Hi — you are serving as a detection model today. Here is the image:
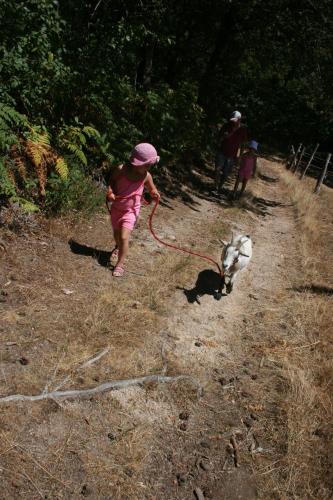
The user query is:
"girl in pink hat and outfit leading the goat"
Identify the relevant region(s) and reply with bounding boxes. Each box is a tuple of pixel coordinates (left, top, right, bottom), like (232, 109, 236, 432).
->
(106, 143, 160, 277)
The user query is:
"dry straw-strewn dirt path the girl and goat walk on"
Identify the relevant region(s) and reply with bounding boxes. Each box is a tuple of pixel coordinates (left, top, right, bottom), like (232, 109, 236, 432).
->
(0, 161, 297, 499)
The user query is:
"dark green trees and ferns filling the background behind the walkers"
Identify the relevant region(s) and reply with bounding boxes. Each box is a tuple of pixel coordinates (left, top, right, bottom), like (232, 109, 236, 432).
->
(0, 0, 333, 219)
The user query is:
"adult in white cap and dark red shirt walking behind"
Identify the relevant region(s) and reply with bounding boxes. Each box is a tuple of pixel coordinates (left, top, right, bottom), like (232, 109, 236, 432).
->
(214, 111, 247, 194)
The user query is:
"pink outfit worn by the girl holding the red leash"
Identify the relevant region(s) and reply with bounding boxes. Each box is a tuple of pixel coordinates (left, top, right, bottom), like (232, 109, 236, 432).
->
(111, 172, 145, 231)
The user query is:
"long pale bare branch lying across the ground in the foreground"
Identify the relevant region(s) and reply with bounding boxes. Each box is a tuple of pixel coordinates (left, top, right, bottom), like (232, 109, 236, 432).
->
(0, 375, 203, 403)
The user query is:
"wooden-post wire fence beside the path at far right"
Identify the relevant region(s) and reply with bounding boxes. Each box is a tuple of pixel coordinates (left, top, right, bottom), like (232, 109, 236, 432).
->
(286, 143, 333, 193)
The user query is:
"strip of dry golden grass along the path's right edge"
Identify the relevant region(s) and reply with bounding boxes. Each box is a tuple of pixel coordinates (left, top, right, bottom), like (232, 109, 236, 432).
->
(265, 171, 333, 499)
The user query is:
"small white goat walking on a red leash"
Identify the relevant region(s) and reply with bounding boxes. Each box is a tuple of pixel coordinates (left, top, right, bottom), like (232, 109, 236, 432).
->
(221, 234, 252, 293)
